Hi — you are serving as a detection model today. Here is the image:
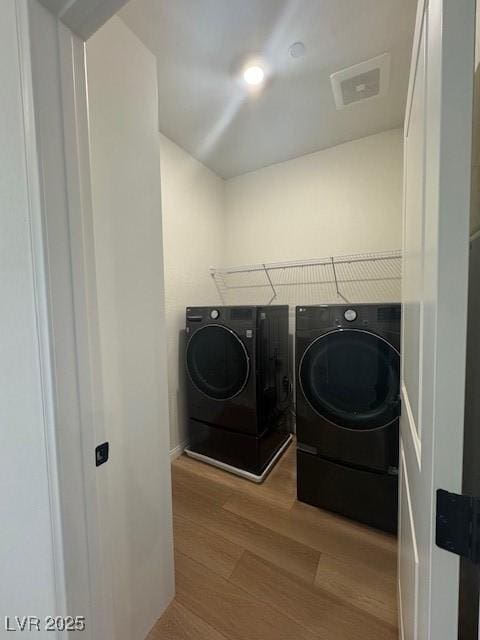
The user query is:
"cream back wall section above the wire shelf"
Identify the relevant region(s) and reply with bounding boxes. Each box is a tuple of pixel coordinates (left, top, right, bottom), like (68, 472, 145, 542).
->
(225, 130, 403, 265)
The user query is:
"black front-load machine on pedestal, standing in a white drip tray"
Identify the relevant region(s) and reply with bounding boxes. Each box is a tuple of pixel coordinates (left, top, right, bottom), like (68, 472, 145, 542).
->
(185, 306, 291, 481)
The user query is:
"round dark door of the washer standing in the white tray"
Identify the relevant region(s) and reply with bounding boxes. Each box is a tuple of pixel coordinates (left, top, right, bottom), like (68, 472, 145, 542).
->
(187, 324, 250, 400)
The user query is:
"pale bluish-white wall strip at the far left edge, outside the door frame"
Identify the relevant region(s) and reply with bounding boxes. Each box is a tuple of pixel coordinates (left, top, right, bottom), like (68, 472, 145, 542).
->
(0, 0, 61, 638)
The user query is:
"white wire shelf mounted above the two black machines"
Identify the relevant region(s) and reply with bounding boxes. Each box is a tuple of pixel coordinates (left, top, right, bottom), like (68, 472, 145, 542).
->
(210, 251, 402, 306)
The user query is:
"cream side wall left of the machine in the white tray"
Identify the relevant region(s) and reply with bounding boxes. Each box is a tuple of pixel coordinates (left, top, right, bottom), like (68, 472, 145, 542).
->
(160, 134, 225, 457)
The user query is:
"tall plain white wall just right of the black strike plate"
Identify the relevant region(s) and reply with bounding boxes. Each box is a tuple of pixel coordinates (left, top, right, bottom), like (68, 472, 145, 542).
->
(87, 18, 174, 640)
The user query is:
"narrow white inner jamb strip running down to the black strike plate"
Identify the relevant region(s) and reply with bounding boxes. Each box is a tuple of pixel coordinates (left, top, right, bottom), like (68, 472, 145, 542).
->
(59, 24, 114, 640)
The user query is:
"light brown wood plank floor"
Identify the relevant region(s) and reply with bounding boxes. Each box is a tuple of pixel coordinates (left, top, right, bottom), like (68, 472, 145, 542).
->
(147, 445, 398, 640)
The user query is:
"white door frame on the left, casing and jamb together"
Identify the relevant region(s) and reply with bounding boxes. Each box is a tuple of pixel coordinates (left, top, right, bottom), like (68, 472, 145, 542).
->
(15, 0, 129, 640)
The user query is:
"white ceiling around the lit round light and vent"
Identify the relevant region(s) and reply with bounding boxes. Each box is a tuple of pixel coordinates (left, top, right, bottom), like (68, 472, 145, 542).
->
(119, 0, 416, 178)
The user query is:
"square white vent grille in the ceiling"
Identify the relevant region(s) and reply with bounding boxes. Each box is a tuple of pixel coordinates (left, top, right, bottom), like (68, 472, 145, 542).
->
(330, 53, 390, 109)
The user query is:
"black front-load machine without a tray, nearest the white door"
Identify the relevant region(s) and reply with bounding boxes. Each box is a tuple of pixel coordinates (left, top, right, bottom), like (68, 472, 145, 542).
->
(296, 304, 401, 532)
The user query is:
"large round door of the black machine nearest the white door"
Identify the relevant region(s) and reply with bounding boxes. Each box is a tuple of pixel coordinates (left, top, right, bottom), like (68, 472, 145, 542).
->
(299, 329, 400, 430)
